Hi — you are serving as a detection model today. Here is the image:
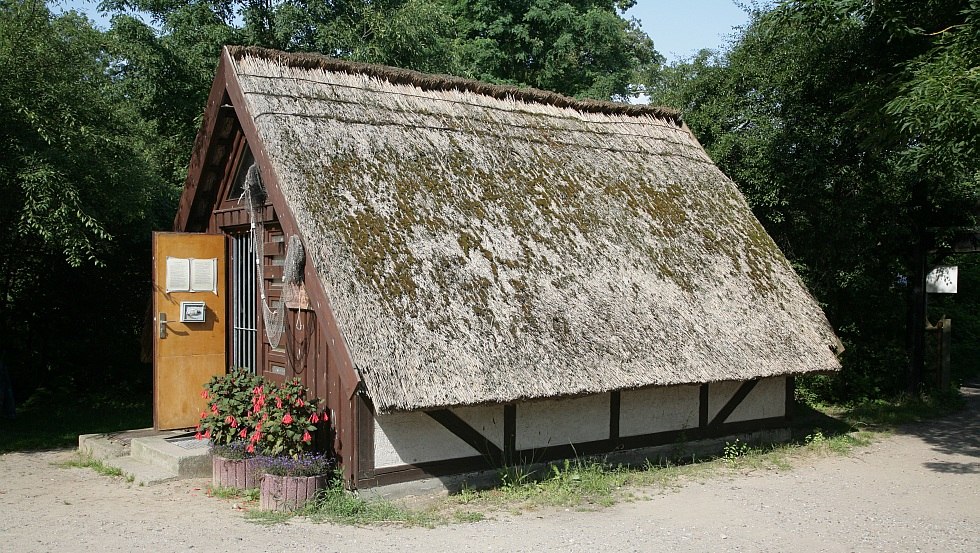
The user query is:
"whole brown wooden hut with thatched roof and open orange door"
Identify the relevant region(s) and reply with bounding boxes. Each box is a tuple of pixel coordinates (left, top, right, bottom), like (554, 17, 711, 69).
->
(154, 47, 841, 488)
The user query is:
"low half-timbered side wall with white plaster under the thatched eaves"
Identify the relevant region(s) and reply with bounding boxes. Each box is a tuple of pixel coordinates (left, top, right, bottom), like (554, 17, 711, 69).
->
(358, 377, 793, 487)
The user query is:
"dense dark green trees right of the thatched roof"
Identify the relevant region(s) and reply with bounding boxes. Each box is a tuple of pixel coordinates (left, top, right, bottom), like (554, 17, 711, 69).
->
(653, 0, 980, 398)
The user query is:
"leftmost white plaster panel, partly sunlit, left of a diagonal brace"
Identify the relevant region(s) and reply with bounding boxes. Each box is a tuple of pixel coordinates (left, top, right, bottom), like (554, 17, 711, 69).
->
(374, 413, 479, 468)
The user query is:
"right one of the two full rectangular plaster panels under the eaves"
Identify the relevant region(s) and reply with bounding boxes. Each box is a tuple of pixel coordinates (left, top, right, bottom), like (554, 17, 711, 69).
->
(619, 386, 701, 436)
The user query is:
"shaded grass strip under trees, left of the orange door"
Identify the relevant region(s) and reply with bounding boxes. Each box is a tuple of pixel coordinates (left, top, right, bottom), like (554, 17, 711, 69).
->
(0, 388, 153, 454)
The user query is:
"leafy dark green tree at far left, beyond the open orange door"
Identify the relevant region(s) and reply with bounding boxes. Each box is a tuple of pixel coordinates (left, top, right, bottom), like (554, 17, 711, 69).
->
(0, 0, 173, 394)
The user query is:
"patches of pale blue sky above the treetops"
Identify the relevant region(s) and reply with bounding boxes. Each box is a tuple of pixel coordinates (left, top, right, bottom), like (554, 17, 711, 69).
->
(60, 0, 748, 61)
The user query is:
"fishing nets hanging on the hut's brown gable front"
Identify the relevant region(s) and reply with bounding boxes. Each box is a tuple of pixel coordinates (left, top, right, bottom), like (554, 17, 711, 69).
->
(239, 163, 306, 348)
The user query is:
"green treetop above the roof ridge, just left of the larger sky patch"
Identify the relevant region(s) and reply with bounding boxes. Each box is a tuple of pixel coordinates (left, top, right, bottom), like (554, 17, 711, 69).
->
(446, 0, 663, 100)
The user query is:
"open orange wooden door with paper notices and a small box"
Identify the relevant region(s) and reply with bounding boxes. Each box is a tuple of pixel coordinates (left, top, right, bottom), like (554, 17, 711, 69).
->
(153, 232, 227, 430)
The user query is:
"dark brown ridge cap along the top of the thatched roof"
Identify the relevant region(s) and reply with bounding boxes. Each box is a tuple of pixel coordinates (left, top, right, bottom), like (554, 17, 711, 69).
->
(225, 46, 683, 127)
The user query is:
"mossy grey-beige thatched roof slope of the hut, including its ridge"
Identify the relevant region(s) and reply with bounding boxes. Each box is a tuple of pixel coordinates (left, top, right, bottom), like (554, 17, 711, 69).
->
(224, 49, 840, 412)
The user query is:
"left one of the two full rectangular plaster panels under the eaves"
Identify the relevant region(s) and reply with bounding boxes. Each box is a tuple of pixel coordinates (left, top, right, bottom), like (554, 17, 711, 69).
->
(517, 394, 609, 450)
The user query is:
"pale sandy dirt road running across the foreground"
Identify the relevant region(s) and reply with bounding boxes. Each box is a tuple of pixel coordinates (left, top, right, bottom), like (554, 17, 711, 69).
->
(0, 388, 980, 553)
